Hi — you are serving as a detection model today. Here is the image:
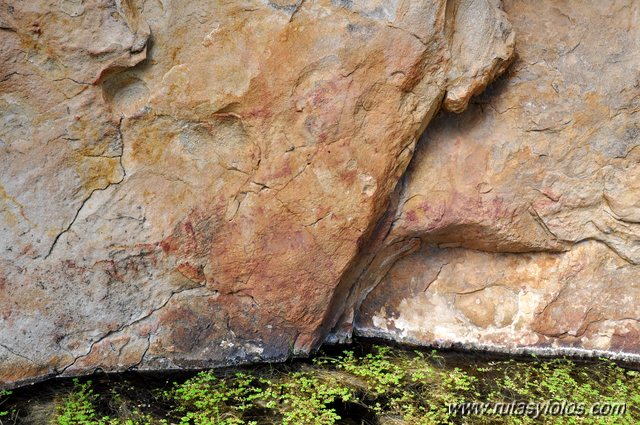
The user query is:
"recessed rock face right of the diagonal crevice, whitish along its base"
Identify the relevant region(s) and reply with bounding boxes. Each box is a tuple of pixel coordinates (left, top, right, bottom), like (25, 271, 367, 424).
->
(350, 0, 640, 358)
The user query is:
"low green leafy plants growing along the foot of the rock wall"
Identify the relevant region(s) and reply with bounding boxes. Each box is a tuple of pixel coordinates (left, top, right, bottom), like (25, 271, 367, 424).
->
(0, 345, 640, 425)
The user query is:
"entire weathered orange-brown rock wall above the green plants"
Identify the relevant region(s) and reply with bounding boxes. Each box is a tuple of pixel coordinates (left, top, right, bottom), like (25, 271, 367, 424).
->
(0, 0, 640, 386)
